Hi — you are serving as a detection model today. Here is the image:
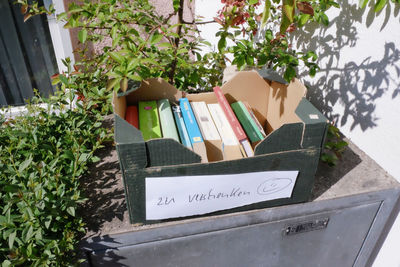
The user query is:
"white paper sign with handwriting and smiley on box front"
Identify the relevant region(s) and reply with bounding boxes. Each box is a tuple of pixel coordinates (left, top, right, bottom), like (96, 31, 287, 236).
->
(146, 171, 299, 220)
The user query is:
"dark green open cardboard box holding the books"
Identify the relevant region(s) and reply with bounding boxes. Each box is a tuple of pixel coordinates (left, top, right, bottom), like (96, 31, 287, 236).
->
(113, 71, 327, 223)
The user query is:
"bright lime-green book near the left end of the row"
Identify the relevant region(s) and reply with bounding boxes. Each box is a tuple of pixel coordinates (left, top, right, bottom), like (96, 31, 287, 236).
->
(139, 101, 162, 141)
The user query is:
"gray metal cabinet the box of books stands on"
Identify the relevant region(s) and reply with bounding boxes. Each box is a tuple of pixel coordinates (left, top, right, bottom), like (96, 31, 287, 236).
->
(82, 141, 400, 267)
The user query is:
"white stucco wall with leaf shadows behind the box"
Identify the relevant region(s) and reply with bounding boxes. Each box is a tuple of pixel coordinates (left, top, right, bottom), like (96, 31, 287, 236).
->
(196, 0, 400, 267)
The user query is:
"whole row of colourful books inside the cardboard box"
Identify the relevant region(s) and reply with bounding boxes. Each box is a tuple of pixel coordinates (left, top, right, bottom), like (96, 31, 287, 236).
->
(125, 87, 266, 162)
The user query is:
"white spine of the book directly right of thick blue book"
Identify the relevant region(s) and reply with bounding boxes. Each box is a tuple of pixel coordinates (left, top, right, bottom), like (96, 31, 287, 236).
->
(190, 102, 221, 140)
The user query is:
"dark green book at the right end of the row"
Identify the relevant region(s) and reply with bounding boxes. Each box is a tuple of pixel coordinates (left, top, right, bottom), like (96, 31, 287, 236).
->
(231, 101, 264, 143)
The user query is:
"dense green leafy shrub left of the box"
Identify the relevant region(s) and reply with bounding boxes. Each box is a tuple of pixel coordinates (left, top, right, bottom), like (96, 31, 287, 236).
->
(0, 91, 108, 266)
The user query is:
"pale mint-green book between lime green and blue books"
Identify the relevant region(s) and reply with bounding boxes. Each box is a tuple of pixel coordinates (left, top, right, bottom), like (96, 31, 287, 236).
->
(157, 99, 180, 142)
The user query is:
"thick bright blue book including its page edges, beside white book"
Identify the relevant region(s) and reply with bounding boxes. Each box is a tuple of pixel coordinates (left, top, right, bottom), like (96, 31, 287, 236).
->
(179, 98, 208, 162)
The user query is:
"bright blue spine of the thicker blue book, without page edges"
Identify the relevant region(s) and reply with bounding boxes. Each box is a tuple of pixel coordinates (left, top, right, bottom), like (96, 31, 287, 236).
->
(179, 98, 204, 144)
